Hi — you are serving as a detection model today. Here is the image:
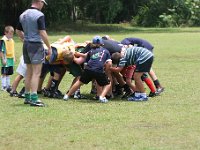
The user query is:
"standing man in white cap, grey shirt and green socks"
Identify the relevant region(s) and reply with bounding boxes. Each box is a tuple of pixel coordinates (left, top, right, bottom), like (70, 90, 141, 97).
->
(16, 0, 52, 107)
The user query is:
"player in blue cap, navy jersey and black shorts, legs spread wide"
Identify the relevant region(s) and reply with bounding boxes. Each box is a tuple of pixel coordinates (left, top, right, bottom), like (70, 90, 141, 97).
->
(63, 36, 112, 103)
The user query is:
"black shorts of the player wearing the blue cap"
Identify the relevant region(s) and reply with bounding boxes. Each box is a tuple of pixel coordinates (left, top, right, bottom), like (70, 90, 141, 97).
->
(80, 70, 110, 86)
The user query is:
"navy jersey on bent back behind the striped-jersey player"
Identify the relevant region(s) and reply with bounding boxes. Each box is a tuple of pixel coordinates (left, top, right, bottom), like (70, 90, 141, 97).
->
(121, 38, 154, 51)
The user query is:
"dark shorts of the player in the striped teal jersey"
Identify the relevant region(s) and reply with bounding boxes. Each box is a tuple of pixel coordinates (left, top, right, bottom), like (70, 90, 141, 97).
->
(135, 56, 153, 72)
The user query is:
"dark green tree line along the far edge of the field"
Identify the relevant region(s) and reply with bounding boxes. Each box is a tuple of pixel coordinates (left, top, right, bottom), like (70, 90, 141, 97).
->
(0, 0, 200, 31)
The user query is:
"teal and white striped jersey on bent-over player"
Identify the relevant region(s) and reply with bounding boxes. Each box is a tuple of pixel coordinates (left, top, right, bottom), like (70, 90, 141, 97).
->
(118, 47, 153, 67)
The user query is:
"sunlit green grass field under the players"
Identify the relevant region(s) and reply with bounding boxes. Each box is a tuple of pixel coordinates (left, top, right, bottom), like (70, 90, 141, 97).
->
(0, 28, 200, 150)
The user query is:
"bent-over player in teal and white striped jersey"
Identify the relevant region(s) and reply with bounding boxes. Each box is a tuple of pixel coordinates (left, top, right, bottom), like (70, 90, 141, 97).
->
(110, 47, 154, 101)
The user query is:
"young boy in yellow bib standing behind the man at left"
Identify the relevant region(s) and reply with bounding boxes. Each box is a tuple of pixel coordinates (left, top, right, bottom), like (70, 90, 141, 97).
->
(0, 26, 15, 92)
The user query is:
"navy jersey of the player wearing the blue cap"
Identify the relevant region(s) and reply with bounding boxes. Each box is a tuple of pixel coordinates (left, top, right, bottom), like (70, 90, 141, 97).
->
(85, 47, 111, 73)
